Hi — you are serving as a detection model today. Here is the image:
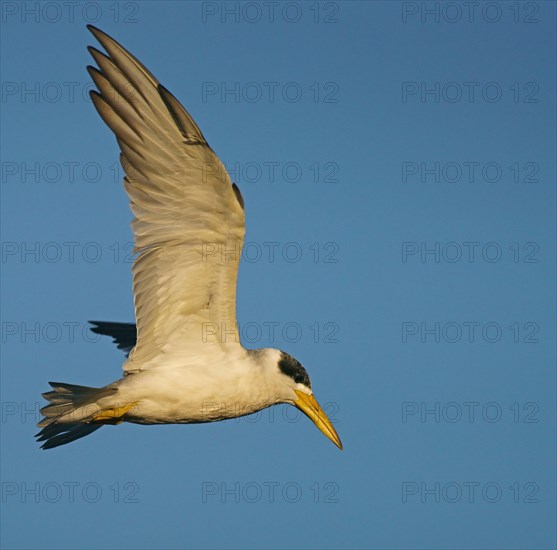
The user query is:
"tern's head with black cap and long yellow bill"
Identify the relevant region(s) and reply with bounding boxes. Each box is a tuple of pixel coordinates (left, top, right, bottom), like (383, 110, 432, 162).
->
(260, 350, 342, 449)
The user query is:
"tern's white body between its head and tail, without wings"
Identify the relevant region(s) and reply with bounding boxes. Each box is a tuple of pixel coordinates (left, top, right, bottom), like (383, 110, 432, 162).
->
(103, 348, 296, 424)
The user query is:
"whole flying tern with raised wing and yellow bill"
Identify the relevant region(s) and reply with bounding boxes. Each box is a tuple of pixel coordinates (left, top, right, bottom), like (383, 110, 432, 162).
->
(37, 25, 342, 449)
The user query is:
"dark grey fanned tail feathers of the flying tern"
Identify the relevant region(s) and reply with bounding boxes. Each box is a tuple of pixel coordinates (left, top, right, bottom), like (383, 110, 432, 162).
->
(35, 382, 118, 449)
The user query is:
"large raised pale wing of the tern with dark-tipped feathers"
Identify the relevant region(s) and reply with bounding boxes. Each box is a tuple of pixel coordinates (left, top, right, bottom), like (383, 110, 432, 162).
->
(88, 26, 245, 373)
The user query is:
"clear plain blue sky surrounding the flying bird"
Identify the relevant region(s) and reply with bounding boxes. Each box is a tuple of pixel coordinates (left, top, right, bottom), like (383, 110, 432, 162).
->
(1, 1, 556, 549)
